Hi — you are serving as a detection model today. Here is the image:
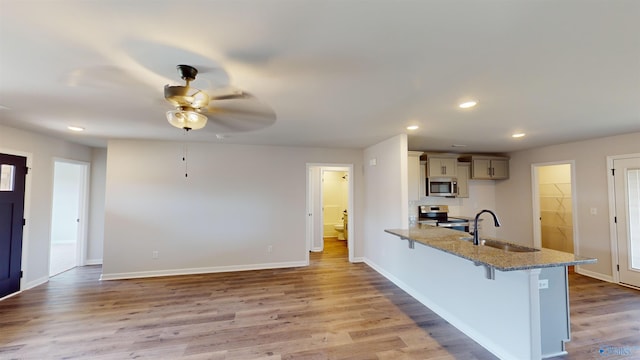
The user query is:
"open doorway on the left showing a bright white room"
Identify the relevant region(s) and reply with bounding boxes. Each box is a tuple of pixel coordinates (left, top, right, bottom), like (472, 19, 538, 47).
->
(49, 160, 89, 276)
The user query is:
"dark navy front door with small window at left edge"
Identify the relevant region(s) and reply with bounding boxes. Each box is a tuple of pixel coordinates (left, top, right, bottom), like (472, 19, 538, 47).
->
(0, 154, 27, 298)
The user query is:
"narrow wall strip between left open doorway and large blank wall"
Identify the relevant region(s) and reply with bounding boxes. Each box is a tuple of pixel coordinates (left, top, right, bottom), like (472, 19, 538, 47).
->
(87, 148, 107, 265)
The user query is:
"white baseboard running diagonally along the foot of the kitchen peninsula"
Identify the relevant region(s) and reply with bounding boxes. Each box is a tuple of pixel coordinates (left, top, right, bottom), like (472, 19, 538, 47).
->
(364, 258, 520, 360)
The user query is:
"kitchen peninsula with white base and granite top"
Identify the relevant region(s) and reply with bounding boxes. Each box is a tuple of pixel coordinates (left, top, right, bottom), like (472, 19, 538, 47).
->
(385, 224, 596, 359)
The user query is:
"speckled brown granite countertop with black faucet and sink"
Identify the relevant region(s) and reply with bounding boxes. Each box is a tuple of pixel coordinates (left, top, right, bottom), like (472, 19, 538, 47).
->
(385, 224, 597, 271)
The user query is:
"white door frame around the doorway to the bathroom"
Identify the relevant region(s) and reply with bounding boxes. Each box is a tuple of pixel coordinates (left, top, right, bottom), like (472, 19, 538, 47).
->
(305, 163, 356, 265)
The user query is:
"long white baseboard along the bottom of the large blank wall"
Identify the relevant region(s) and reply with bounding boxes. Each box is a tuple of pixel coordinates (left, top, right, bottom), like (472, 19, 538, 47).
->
(100, 261, 308, 280)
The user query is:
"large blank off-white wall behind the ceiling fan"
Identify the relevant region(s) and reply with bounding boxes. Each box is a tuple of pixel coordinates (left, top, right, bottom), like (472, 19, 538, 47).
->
(103, 140, 363, 279)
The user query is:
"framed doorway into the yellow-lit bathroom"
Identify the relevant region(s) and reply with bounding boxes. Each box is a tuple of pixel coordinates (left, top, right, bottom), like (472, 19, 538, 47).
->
(306, 164, 354, 263)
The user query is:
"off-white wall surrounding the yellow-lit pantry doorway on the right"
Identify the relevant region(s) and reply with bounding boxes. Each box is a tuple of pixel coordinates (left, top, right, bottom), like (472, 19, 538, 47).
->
(496, 132, 640, 279)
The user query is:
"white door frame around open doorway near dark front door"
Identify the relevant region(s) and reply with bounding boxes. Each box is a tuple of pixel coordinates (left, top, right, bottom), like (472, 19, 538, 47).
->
(48, 157, 91, 266)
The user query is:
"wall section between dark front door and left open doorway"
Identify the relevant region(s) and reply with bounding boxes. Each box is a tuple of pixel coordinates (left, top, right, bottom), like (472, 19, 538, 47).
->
(0, 125, 91, 289)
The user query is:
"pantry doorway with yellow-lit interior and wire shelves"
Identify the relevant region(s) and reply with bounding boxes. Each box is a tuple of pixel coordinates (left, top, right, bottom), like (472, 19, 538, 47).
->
(533, 162, 575, 254)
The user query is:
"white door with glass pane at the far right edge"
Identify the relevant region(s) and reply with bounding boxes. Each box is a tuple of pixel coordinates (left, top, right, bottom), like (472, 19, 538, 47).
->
(613, 157, 640, 287)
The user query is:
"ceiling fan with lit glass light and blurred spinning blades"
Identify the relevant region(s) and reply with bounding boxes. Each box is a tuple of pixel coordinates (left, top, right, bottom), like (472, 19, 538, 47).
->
(164, 65, 276, 133)
